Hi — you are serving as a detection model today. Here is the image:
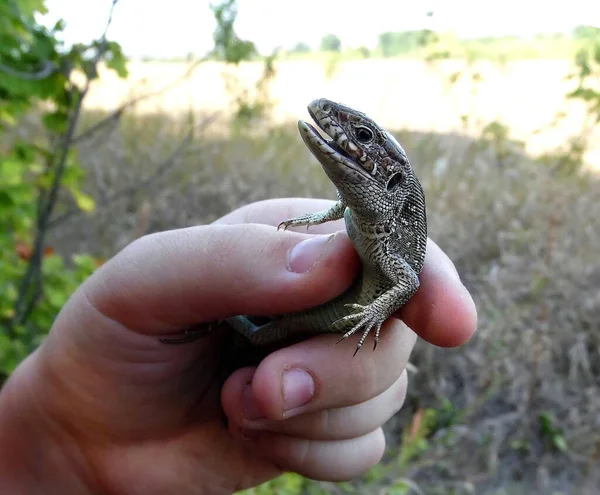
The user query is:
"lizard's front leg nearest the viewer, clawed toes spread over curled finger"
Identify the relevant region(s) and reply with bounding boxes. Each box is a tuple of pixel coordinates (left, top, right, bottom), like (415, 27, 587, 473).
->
(333, 254, 420, 355)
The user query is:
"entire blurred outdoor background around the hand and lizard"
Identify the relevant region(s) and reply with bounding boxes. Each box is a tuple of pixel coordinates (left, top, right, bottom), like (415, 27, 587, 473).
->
(0, 0, 600, 494)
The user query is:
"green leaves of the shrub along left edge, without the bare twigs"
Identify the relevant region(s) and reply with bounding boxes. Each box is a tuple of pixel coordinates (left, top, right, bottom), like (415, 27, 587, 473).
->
(0, 0, 127, 376)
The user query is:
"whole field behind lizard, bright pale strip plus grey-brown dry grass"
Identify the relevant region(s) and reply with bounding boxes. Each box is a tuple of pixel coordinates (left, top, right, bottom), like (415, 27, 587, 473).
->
(43, 60, 600, 495)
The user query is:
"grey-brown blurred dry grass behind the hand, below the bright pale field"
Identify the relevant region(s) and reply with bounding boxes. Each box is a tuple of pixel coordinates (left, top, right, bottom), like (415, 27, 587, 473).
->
(41, 100, 600, 494)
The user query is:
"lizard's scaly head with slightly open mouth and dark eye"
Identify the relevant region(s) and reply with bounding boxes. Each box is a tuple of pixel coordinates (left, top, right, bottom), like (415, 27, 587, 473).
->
(298, 98, 416, 218)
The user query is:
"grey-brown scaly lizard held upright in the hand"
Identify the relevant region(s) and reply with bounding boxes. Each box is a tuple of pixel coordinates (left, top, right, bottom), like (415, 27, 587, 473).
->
(161, 98, 427, 355)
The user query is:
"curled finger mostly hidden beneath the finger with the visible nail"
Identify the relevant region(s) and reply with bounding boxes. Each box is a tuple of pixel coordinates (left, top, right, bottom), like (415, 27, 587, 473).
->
(221, 368, 407, 440)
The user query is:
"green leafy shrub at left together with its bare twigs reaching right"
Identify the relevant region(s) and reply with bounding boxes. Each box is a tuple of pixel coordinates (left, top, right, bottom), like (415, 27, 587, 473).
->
(0, 0, 258, 381)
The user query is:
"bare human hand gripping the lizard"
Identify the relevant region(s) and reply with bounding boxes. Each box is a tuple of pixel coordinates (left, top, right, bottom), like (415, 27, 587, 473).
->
(0, 199, 477, 495)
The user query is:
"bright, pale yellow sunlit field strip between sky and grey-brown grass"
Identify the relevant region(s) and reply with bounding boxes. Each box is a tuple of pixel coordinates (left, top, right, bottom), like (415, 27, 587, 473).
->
(87, 59, 600, 167)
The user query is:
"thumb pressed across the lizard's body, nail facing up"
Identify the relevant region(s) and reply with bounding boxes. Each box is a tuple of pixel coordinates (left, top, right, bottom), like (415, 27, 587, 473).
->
(72, 224, 359, 334)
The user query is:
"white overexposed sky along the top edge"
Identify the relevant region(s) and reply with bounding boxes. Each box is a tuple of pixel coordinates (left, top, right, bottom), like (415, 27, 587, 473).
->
(41, 0, 600, 57)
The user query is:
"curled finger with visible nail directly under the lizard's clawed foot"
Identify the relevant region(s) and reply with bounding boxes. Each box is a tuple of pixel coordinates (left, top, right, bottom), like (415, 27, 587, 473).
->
(225, 319, 416, 421)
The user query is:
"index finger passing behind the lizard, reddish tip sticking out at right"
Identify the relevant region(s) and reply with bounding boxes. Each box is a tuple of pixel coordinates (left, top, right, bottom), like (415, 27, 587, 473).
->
(219, 198, 477, 347)
